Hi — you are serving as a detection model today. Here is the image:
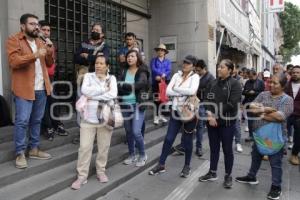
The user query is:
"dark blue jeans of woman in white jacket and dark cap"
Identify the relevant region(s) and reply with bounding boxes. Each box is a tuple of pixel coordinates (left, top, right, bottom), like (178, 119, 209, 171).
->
(159, 111, 196, 166)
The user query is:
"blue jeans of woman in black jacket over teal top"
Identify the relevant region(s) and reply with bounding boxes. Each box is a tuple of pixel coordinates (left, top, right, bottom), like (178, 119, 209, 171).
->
(122, 104, 145, 156)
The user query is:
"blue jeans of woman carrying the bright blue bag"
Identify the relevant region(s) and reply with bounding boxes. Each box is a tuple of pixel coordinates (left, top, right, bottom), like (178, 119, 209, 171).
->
(248, 144, 284, 187)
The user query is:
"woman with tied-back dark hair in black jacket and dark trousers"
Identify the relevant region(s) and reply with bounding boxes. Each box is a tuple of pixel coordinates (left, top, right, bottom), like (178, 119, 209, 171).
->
(199, 59, 242, 188)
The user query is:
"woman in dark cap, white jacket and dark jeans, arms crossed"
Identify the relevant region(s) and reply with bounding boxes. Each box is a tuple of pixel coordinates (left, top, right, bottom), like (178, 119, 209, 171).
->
(149, 55, 200, 178)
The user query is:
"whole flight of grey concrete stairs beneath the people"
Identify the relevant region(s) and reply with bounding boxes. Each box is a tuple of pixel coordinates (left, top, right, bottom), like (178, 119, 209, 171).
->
(0, 110, 170, 200)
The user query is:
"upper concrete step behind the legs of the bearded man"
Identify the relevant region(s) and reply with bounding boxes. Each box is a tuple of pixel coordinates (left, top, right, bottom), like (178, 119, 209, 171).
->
(0, 111, 158, 164)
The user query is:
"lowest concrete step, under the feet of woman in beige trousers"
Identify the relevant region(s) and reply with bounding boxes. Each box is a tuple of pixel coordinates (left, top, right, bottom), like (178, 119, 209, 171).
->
(45, 132, 179, 200)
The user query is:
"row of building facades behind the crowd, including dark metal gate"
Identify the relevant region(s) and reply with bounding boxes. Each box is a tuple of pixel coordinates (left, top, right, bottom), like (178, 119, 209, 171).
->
(0, 0, 281, 112)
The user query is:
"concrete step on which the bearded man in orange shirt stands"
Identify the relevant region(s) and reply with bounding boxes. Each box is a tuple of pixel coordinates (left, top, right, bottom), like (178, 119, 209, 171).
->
(0, 121, 161, 188)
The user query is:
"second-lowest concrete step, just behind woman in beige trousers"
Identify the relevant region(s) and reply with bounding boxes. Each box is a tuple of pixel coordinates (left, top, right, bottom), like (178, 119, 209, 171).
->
(0, 127, 166, 200)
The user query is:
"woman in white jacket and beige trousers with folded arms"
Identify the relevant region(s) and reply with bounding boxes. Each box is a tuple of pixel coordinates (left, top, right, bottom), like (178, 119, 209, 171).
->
(71, 55, 118, 190)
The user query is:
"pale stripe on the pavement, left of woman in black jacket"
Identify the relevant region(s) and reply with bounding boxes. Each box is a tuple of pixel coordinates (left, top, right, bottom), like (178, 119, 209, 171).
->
(164, 160, 209, 200)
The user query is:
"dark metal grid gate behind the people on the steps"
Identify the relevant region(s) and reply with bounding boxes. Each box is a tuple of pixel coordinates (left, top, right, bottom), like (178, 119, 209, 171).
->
(45, 0, 126, 82)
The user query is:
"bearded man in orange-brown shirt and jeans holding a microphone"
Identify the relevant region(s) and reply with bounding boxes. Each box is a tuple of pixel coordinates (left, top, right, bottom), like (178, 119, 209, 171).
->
(6, 14, 54, 169)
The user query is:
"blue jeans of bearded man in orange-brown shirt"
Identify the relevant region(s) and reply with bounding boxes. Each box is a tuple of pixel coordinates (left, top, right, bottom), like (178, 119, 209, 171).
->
(14, 90, 46, 155)
